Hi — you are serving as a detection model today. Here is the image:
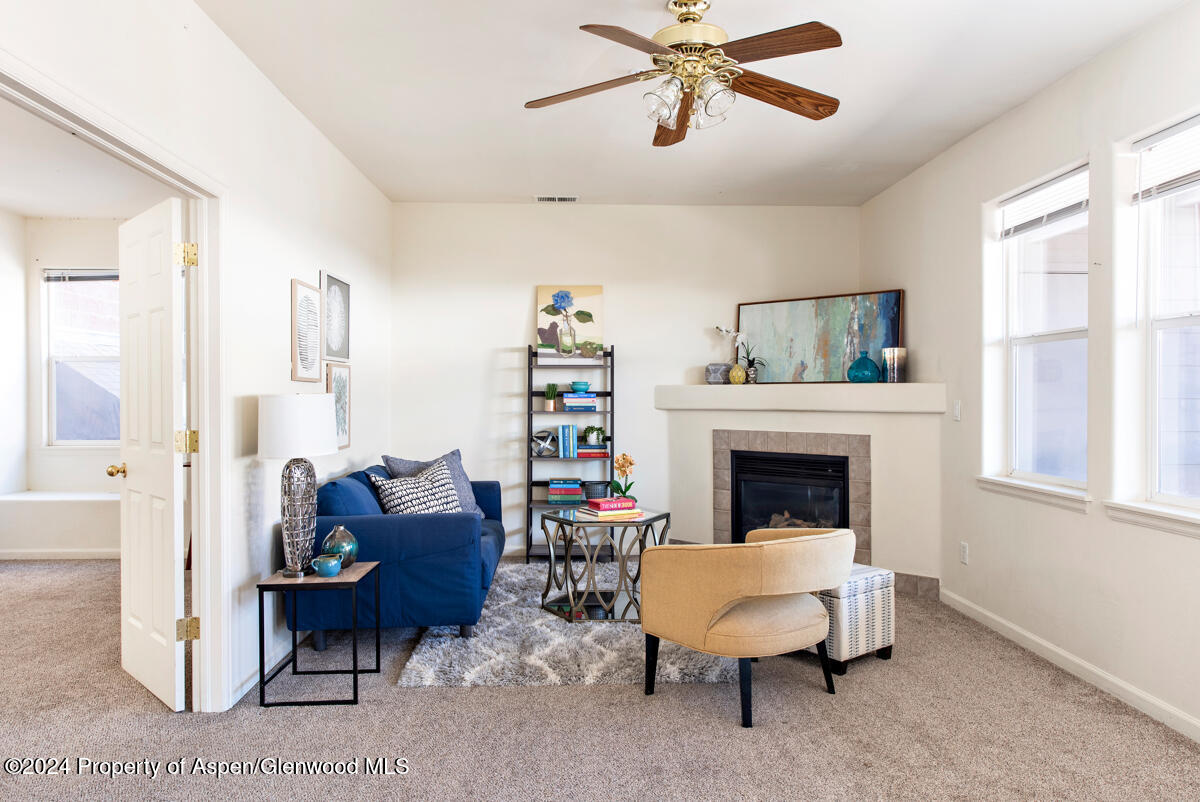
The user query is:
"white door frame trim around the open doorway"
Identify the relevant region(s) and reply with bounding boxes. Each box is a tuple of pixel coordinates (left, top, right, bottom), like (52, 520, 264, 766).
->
(0, 64, 236, 712)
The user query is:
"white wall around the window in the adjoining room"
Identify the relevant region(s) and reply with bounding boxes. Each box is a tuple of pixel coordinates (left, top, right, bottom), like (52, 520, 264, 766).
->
(25, 217, 121, 489)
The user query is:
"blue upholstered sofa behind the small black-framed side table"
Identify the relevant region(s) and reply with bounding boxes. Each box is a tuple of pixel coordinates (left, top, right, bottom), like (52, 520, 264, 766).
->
(286, 465, 504, 648)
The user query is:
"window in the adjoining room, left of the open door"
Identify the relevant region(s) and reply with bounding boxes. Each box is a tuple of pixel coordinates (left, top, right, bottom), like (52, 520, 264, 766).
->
(43, 270, 121, 445)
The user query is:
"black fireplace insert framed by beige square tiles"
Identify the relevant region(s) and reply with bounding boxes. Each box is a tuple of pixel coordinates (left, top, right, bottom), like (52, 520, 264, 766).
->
(730, 450, 850, 543)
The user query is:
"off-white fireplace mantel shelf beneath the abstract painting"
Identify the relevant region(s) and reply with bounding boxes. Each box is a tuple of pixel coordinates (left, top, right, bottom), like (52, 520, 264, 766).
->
(654, 382, 946, 414)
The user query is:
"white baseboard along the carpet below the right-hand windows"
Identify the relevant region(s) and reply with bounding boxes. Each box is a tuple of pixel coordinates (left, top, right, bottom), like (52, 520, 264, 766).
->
(942, 588, 1200, 741)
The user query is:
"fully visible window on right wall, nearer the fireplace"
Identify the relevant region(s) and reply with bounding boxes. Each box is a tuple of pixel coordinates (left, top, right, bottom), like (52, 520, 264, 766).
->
(1000, 167, 1088, 487)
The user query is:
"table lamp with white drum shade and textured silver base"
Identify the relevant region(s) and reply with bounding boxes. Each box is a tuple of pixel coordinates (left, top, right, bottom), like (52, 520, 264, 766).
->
(258, 393, 337, 579)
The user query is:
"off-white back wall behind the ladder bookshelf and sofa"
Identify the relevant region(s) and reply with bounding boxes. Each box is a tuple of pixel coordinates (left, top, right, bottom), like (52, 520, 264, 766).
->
(393, 204, 858, 551)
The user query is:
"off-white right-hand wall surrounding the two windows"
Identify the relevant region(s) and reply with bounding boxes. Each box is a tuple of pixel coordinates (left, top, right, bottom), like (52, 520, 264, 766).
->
(863, 4, 1200, 737)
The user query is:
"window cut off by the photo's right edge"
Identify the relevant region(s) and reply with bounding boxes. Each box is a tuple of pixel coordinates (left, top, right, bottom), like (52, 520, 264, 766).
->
(1134, 119, 1200, 504)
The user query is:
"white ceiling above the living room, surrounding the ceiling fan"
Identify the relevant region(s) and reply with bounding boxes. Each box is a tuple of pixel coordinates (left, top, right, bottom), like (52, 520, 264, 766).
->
(198, 0, 1181, 204)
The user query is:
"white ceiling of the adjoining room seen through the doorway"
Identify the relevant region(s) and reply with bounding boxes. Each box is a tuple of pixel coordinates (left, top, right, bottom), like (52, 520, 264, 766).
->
(0, 100, 172, 220)
